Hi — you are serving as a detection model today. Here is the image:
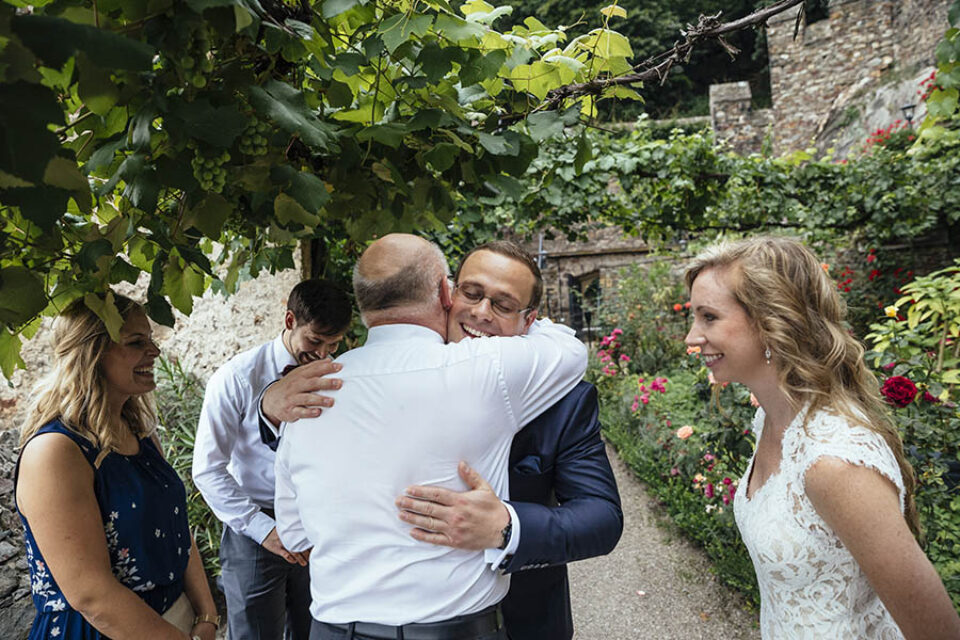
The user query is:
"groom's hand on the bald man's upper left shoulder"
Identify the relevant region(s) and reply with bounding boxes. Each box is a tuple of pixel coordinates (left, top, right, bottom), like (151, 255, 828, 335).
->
(261, 359, 343, 427)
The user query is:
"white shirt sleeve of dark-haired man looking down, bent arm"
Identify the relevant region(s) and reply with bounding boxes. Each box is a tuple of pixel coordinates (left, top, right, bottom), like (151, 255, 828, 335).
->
(193, 369, 276, 544)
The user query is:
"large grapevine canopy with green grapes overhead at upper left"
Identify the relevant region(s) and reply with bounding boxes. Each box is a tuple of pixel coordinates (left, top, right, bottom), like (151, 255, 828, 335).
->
(0, 0, 652, 375)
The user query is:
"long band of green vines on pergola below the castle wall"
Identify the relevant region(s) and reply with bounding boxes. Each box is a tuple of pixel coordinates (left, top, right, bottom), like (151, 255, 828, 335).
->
(448, 119, 960, 245)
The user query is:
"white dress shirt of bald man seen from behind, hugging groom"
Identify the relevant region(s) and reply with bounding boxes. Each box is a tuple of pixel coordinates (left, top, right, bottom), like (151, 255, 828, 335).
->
(275, 322, 586, 625)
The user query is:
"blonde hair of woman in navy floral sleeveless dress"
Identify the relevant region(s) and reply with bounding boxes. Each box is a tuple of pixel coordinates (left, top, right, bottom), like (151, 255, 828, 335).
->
(20, 294, 157, 466)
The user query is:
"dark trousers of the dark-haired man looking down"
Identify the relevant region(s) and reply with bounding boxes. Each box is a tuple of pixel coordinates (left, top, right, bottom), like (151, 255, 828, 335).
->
(220, 526, 313, 640)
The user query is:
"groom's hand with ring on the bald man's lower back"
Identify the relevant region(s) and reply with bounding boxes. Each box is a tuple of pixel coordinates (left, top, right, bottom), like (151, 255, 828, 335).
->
(396, 462, 510, 551)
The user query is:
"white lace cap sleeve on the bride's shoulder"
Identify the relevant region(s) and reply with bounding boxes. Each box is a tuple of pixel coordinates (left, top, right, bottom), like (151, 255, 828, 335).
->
(801, 415, 906, 513)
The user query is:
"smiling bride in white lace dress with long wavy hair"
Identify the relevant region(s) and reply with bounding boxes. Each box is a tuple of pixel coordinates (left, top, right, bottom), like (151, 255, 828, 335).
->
(686, 237, 960, 640)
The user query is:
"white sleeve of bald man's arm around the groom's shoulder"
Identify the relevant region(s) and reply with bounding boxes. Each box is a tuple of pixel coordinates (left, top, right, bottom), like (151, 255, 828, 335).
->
(500, 320, 587, 430)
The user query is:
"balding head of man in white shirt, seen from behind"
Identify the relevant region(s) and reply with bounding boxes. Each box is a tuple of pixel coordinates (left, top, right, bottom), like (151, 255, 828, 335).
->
(353, 233, 449, 324)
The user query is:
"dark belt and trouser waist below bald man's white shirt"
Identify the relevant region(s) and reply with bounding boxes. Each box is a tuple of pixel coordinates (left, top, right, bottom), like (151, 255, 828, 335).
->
(318, 605, 503, 640)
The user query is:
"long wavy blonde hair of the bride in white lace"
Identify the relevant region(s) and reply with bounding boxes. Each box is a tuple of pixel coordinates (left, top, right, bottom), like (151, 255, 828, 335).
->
(685, 236, 922, 540)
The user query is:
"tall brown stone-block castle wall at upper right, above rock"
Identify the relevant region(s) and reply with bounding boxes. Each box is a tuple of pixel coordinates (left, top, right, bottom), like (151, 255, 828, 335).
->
(767, 0, 950, 154)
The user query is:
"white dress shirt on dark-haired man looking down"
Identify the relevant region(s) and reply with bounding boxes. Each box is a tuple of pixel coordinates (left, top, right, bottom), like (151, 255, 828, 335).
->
(193, 334, 296, 543)
